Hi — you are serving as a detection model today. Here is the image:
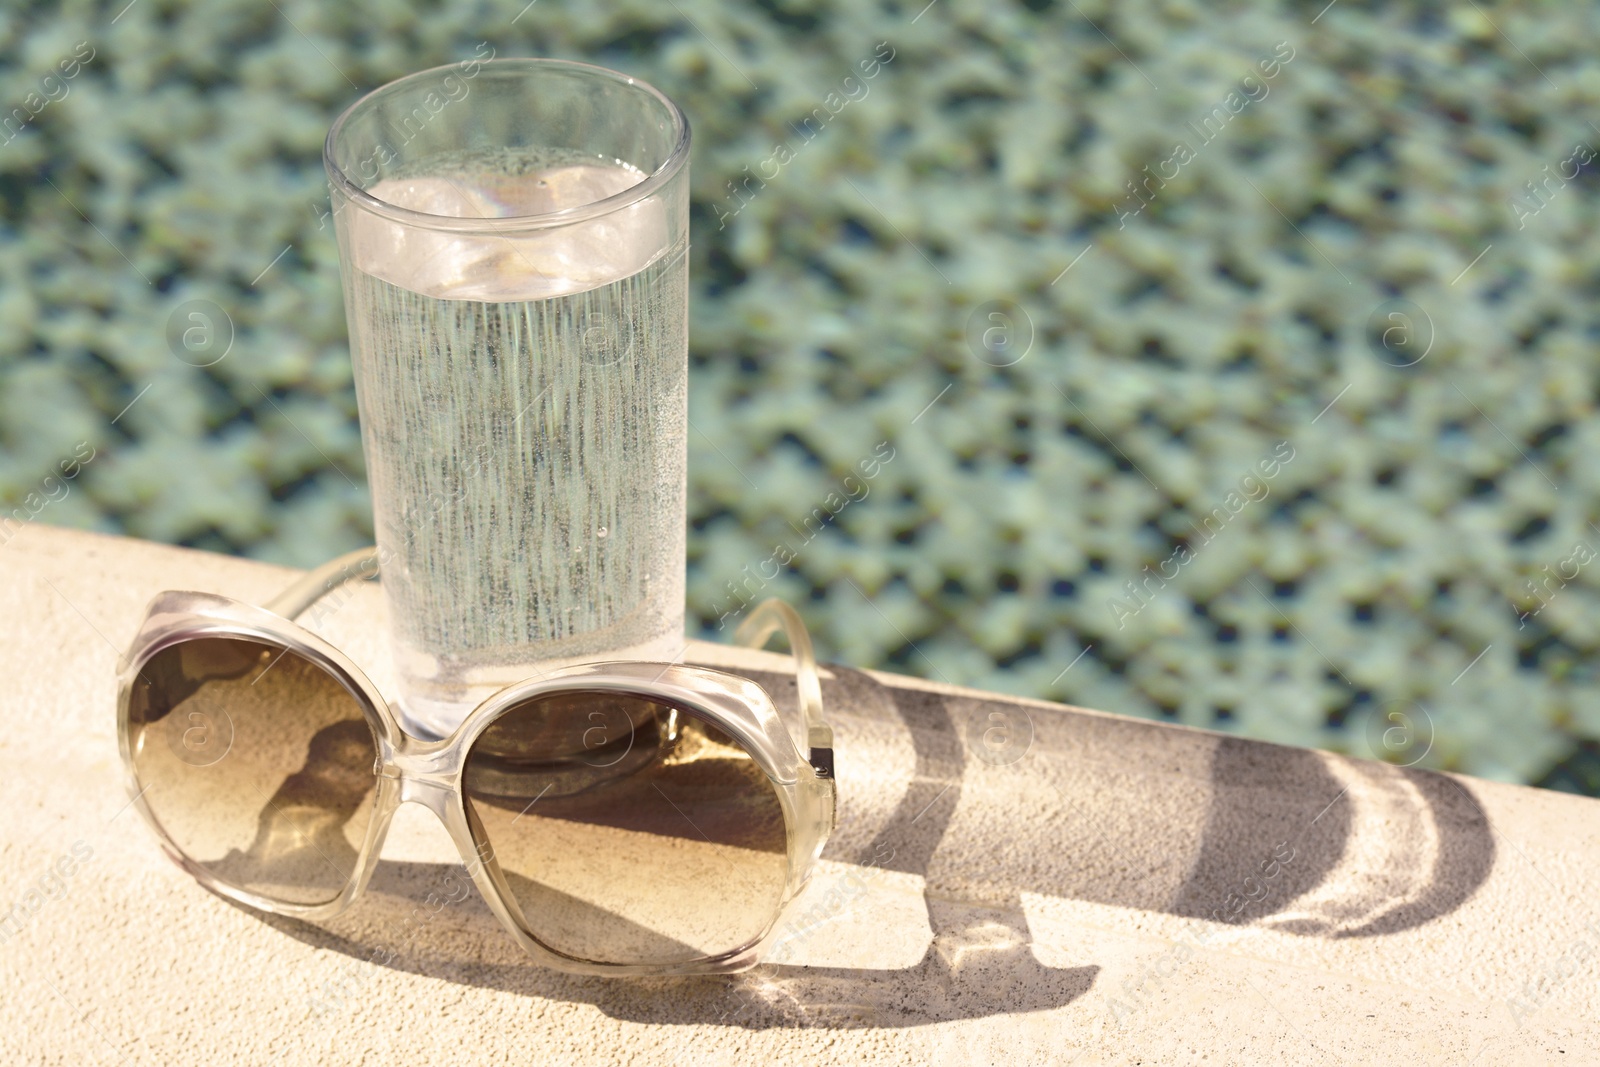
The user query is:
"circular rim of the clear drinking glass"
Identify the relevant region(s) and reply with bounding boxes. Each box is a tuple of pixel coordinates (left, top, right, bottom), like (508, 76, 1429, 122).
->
(322, 56, 690, 234)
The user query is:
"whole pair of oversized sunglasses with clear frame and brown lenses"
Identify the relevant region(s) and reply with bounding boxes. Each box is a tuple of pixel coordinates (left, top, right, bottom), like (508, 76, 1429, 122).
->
(117, 549, 835, 974)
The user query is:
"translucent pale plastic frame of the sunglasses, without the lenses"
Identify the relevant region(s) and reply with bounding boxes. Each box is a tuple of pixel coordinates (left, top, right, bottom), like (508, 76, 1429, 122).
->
(117, 549, 837, 976)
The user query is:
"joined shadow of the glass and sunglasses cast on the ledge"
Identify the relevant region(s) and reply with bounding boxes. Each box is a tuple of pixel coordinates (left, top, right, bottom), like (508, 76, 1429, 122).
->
(232, 667, 1494, 1029)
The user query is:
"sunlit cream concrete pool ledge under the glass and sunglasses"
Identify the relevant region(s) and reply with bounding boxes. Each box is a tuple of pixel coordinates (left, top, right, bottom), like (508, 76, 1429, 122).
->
(0, 525, 1600, 1067)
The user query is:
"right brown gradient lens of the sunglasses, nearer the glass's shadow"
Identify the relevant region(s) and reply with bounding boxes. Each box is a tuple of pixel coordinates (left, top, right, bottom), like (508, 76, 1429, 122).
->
(462, 693, 789, 965)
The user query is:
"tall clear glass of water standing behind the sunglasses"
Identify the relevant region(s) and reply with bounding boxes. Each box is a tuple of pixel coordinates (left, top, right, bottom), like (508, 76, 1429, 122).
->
(323, 59, 690, 736)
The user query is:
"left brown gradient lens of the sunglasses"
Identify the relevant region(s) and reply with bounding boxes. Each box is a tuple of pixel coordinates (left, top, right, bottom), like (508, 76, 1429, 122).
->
(128, 637, 378, 904)
